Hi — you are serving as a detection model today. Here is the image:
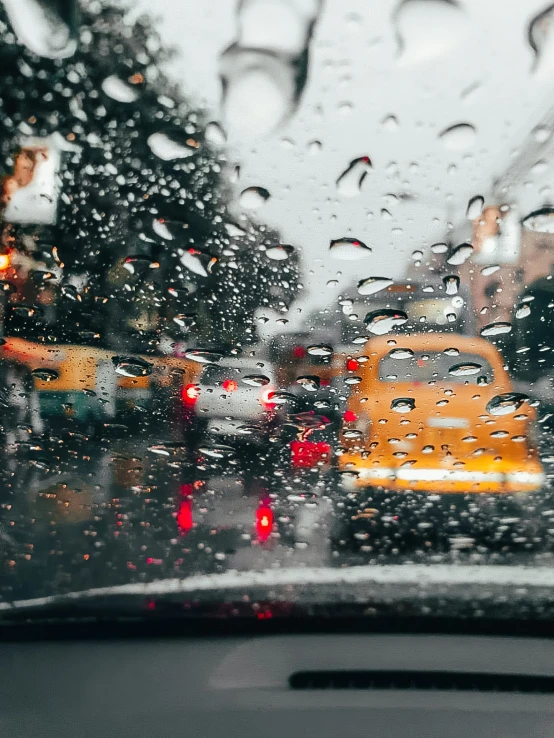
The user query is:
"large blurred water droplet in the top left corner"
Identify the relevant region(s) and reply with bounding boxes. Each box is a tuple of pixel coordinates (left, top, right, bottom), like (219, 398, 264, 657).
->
(3, 0, 77, 59)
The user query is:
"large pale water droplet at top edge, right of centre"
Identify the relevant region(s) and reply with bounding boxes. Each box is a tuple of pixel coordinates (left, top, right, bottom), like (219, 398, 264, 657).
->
(395, 0, 470, 64)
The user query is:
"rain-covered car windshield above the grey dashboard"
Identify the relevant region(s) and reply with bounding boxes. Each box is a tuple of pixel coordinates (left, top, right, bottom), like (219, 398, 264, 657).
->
(0, 0, 554, 619)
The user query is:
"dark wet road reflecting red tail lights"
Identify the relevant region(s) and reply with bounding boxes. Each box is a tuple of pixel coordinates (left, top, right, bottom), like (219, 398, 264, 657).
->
(0, 422, 554, 601)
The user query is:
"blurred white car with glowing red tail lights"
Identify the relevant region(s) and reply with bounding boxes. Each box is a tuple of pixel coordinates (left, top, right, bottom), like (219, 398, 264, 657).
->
(182, 357, 279, 445)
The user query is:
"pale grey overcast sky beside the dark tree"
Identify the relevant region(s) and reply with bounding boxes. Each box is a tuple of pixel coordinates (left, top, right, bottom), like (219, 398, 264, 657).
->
(135, 0, 554, 328)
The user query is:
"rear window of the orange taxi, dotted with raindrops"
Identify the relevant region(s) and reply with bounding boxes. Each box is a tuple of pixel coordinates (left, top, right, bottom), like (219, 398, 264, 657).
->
(379, 350, 494, 384)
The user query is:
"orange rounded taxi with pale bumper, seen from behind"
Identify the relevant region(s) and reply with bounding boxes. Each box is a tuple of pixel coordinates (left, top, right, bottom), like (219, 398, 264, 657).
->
(339, 333, 544, 493)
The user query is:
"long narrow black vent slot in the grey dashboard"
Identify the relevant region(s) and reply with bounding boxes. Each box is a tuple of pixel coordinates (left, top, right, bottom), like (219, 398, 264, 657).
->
(289, 670, 554, 694)
